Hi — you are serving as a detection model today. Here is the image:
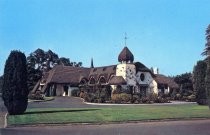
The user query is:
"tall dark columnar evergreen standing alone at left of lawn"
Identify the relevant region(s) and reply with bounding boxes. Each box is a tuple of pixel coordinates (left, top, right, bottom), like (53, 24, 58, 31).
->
(2, 51, 29, 115)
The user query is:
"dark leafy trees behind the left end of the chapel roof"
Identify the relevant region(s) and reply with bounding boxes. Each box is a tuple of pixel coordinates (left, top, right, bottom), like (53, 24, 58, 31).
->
(27, 48, 82, 91)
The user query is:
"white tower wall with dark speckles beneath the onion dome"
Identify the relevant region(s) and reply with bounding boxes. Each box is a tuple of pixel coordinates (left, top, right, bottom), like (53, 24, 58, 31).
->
(116, 63, 136, 86)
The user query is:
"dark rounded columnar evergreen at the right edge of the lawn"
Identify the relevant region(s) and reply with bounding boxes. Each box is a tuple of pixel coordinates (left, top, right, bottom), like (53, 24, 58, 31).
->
(193, 61, 207, 105)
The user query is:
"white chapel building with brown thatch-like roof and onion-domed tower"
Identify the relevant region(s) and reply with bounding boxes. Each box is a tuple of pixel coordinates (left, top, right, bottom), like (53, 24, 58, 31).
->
(32, 46, 178, 97)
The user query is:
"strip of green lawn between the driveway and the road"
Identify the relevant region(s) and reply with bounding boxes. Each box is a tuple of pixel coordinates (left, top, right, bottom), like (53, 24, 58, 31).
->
(8, 105, 210, 125)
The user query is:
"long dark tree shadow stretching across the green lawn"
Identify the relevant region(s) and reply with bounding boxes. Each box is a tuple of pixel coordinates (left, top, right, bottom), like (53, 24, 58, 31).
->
(24, 109, 100, 114)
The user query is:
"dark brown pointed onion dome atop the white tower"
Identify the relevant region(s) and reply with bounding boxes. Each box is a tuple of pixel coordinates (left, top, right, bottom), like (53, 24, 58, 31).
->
(118, 46, 134, 62)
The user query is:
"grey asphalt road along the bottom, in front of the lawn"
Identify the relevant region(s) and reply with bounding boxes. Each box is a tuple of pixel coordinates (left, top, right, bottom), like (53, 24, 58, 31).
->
(1, 120, 210, 135)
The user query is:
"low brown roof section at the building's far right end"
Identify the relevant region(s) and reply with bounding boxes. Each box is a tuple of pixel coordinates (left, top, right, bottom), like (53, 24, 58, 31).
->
(155, 74, 179, 89)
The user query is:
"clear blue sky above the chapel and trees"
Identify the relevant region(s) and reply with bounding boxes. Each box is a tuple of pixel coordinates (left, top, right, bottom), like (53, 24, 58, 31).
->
(0, 0, 210, 75)
